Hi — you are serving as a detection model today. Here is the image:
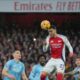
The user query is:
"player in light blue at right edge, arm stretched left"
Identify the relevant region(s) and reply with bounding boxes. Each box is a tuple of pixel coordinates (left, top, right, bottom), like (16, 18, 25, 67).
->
(65, 56, 80, 80)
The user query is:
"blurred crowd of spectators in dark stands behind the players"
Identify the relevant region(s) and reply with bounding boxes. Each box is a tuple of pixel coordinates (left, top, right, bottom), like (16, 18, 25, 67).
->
(0, 26, 80, 80)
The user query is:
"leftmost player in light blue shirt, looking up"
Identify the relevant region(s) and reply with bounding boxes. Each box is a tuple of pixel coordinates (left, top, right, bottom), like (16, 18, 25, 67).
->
(2, 50, 28, 80)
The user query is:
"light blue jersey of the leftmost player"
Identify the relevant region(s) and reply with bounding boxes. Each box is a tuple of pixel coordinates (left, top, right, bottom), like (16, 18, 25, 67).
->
(3, 59, 25, 80)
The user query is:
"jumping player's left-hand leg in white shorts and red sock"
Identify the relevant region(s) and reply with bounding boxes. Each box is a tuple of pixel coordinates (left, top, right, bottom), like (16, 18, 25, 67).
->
(40, 58, 54, 80)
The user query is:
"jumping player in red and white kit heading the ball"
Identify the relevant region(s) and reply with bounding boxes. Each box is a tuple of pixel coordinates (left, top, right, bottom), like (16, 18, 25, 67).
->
(41, 21, 73, 80)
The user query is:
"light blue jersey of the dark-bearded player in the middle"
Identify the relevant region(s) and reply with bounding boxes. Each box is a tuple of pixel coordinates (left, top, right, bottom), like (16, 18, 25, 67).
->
(29, 64, 49, 80)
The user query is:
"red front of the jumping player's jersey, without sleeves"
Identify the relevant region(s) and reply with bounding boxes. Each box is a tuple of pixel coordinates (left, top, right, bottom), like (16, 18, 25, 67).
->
(49, 37, 64, 58)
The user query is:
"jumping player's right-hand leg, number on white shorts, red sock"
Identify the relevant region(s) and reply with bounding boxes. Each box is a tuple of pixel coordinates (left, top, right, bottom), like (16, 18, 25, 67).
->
(56, 59, 65, 80)
